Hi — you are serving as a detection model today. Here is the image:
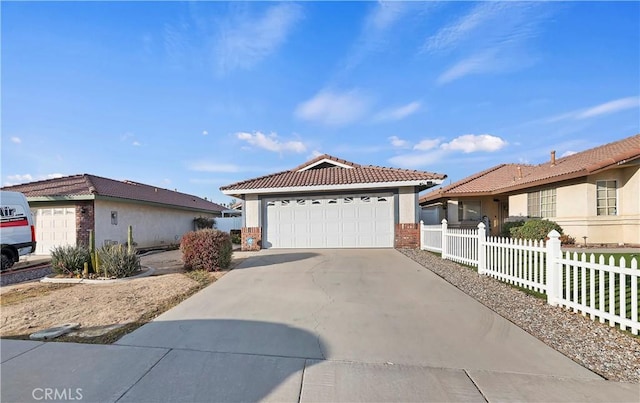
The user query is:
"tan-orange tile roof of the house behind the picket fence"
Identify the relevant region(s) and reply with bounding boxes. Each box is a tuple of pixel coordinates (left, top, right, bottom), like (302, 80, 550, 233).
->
(420, 134, 640, 203)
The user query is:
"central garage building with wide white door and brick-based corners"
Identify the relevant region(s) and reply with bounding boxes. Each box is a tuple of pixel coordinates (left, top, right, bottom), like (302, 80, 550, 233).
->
(220, 154, 446, 250)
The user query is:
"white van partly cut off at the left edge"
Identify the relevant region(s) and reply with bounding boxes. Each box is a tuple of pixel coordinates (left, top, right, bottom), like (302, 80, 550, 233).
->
(0, 190, 36, 270)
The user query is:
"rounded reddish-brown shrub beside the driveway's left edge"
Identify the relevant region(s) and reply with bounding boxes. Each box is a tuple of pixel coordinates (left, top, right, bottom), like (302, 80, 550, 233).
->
(180, 229, 233, 271)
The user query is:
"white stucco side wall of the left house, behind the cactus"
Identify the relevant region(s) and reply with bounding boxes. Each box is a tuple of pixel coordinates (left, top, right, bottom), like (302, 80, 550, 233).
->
(95, 200, 212, 247)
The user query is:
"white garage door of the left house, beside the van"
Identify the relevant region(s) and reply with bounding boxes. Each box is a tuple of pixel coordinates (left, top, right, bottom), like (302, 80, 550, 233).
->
(32, 207, 76, 255)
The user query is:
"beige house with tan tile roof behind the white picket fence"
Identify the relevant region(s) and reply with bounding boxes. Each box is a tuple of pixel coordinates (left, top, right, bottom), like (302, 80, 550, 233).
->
(420, 134, 640, 245)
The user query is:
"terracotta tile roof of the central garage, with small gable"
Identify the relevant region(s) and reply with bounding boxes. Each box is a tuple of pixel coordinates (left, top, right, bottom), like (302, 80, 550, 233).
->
(220, 154, 446, 191)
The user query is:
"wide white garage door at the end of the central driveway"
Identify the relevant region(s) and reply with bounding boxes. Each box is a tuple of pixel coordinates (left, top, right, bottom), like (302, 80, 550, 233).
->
(263, 193, 394, 248)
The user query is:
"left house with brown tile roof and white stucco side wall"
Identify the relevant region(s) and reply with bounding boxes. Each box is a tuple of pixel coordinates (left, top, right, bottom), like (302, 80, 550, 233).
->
(2, 174, 225, 255)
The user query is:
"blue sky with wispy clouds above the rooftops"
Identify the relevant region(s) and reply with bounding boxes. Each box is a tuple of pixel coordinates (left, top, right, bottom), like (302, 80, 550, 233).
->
(1, 2, 640, 203)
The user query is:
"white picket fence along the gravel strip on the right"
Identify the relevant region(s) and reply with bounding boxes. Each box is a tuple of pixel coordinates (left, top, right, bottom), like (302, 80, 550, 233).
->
(420, 220, 640, 335)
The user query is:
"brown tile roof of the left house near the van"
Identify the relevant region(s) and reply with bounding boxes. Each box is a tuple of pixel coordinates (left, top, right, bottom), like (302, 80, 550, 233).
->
(2, 174, 225, 212)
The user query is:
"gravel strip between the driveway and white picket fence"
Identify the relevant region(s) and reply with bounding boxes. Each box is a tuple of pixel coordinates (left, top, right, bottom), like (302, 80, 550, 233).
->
(401, 249, 640, 383)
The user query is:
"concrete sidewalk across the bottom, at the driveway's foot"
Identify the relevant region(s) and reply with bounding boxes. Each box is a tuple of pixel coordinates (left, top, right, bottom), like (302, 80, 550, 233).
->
(0, 340, 640, 403)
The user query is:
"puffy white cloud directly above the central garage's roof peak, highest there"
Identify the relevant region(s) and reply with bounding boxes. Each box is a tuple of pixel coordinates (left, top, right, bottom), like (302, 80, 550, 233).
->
(295, 90, 370, 126)
